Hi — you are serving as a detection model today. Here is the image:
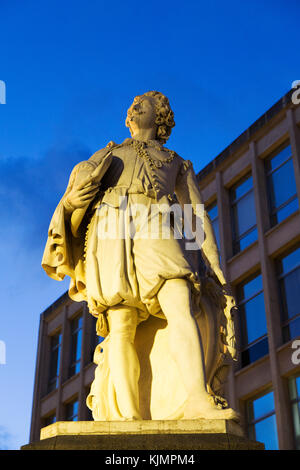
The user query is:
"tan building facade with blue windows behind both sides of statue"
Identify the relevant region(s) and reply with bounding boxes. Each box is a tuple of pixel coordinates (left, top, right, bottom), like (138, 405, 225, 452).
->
(30, 92, 300, 449)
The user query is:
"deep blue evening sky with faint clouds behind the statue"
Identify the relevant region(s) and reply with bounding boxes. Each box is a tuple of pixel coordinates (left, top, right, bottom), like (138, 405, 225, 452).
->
(0, 0, 300, 449)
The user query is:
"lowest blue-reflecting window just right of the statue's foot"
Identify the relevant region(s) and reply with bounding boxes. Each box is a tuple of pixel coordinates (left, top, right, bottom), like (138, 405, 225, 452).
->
(247, 392, 278, 450)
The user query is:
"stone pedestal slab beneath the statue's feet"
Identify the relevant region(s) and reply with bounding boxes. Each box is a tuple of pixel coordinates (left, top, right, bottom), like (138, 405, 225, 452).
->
(21, 419, 264, 450)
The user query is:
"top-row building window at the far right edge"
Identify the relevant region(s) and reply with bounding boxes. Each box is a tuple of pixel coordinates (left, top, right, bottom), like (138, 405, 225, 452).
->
(265, 144, 298, 227)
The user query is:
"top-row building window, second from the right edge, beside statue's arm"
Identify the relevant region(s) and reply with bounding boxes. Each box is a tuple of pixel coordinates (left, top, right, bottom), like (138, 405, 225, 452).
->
(230, 175, 257, 254)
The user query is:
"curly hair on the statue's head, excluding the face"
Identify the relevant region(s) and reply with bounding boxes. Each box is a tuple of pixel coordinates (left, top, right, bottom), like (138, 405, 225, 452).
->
(126, 91, 175, 144)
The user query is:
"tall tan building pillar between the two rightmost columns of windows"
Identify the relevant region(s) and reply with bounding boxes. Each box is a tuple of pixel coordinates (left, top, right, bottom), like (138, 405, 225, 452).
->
(250, 142, 294, 450)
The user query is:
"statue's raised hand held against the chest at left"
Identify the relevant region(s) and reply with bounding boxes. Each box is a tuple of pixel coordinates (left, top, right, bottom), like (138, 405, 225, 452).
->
(64, 177, 99, 212)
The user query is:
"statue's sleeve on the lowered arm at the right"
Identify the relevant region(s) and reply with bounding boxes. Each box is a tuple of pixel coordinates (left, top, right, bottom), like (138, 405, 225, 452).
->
(175, 160, 225, 284)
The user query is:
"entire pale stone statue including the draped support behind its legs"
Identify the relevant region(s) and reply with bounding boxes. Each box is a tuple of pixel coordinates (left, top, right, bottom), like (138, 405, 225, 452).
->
(42, 91, 239, 420)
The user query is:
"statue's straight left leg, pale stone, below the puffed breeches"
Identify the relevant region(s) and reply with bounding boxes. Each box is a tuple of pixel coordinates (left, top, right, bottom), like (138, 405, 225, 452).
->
(108, 306, 142, 420)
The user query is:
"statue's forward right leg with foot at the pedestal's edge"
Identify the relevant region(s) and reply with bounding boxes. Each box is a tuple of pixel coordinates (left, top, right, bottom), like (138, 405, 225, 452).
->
(157, 279, 238, 419)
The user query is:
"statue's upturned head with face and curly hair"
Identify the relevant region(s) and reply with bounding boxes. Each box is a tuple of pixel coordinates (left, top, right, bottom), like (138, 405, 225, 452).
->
(125, 91, 175, 144)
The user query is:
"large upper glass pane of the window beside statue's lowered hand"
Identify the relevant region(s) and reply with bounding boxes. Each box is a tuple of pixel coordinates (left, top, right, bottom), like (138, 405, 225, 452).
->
(239, 293, 267, 347)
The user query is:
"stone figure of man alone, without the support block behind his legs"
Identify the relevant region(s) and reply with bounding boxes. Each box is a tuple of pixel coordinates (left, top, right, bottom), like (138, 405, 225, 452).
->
(42, 91, 238, 420)
